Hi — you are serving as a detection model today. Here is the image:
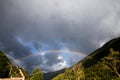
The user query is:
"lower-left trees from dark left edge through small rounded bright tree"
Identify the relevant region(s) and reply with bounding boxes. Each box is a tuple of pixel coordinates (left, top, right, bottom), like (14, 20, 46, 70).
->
(0, 51, 43, 80)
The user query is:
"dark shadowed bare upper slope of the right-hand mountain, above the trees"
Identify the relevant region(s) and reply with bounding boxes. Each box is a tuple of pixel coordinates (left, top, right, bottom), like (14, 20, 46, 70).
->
(80, 37, 120, 68)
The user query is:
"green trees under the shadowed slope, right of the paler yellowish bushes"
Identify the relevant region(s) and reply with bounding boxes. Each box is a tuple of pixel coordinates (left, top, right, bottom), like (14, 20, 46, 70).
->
(84, 49, 120, 80)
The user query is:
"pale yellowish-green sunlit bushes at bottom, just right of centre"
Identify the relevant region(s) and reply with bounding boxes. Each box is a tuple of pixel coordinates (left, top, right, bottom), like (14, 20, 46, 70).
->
(52, 63, 85, 80)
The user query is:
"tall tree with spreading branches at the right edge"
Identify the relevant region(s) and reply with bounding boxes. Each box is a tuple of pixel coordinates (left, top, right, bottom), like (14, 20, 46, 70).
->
(102, 48, 120, 78)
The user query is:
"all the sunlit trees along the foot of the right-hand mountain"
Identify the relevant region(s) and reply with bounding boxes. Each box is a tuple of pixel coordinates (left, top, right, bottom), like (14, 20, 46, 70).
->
(53, 48, 120, 80)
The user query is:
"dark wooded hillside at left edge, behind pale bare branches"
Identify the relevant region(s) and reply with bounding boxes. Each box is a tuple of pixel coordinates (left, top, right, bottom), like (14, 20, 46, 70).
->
(0, 51, 29, 78)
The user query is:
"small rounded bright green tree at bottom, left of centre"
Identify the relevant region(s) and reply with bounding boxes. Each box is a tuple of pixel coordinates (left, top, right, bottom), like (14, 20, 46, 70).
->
(30, 68, 43, 80)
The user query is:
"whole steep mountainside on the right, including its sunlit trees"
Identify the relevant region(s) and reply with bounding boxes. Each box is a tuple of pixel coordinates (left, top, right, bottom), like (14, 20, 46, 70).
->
(52, 37, 120, 80)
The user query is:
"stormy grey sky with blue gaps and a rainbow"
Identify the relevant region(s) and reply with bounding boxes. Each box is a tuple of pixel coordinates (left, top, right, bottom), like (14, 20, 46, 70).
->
(0, 0, 120, 72)
